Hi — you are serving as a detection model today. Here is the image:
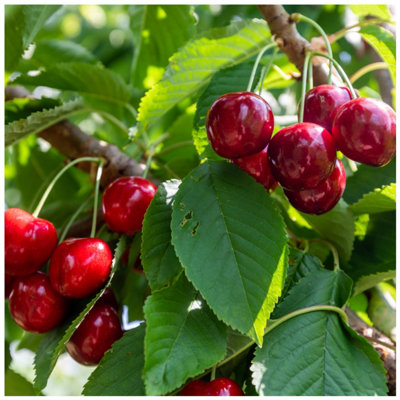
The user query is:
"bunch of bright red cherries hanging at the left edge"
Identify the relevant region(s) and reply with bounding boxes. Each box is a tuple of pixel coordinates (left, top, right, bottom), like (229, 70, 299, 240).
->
(4, 177, 157, 365)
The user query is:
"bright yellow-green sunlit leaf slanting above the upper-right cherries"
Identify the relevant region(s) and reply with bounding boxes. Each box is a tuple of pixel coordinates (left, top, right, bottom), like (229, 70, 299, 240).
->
(138, 20, 271, 131)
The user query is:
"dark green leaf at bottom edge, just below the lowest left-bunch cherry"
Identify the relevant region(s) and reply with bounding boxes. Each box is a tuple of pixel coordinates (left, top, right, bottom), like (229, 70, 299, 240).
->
(82, 324, 145, 396)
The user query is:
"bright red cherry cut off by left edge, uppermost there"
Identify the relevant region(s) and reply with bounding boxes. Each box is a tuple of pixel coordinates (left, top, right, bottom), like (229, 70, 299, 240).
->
(4, 208, 57, 276)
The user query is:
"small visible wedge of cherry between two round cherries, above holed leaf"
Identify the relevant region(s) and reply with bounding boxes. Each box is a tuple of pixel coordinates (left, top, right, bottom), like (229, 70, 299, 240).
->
(232, 145, 278, 192)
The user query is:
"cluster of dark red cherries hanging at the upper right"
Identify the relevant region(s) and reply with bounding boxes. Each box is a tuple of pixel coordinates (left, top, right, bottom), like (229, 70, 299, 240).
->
(206, 85, 396, 214)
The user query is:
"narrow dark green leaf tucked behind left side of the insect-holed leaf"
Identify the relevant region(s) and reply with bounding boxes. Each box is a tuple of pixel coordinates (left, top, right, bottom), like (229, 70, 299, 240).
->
(141, 179, 182, 290)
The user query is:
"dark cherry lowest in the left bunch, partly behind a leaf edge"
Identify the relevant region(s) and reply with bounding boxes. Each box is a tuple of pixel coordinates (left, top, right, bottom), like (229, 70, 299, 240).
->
(65, 303, 123, 365)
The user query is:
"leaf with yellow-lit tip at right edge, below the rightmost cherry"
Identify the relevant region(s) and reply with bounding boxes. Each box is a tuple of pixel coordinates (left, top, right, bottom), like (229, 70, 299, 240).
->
(350, 183, 396, 215)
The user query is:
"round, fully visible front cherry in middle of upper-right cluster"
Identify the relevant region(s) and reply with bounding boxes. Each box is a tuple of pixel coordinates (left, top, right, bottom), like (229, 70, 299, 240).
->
(268, 122, 336, 190)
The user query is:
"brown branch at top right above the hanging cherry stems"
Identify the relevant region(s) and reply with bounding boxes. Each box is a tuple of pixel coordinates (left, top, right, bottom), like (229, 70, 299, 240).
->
(258, 4, 341, 85)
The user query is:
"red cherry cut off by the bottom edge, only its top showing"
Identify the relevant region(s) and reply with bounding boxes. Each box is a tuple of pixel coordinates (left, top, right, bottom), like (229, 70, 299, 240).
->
(180, 378, 243, 396)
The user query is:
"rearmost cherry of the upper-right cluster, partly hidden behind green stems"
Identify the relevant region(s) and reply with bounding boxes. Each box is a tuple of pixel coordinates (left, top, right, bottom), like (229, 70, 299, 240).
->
(303, 85, 351, 132)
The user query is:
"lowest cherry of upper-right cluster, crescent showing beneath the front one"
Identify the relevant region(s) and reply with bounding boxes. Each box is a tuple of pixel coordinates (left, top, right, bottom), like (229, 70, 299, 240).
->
(284, 160, 346, 214)
